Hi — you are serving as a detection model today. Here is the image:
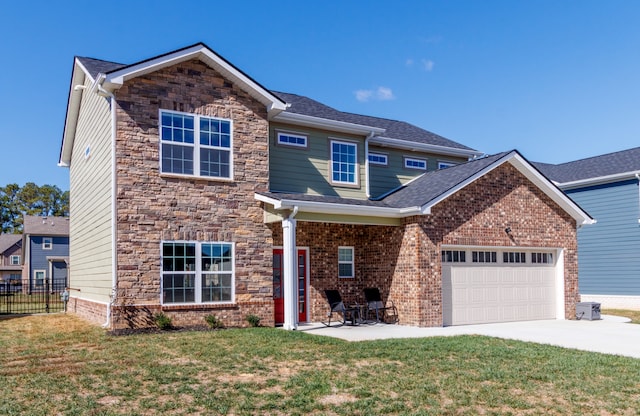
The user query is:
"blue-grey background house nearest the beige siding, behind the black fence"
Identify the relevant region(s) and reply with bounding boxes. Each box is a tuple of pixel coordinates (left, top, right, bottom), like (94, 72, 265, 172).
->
(22, 215, 69, 293)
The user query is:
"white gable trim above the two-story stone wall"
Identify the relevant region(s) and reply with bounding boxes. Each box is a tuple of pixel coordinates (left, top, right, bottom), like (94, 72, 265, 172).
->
(103, 45, 286, 113)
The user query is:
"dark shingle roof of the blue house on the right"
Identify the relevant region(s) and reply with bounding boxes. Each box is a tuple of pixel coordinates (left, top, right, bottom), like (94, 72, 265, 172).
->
(533, 147, 640, 184)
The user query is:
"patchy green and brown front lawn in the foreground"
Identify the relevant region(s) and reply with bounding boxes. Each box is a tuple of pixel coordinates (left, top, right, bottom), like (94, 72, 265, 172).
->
(0, 314, 640, 415)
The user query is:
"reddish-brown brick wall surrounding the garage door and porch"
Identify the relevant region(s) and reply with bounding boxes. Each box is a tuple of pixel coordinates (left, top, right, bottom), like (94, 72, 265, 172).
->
(271, 164, 579, 326)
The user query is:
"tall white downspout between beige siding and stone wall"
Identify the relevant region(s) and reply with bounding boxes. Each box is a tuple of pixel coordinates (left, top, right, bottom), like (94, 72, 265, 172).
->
(96, 81, 118, 328)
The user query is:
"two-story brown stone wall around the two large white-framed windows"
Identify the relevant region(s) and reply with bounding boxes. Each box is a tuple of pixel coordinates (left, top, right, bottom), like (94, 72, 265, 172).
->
(112, 60, 273, 329)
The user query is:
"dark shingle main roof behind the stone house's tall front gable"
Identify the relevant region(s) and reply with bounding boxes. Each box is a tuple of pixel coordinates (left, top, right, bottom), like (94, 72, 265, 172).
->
(77, 57, 475, 151)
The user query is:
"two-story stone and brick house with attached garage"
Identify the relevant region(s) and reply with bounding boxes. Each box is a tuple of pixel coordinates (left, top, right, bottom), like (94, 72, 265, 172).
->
(60, 43, 593, 330)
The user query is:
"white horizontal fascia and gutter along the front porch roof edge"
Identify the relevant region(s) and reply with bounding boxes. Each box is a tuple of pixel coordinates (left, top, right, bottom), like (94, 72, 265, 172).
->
(255, 194, 421, 218)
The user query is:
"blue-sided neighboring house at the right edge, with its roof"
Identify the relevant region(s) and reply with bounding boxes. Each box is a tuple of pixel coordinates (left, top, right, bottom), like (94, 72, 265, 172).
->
(536, 147, 640, 309)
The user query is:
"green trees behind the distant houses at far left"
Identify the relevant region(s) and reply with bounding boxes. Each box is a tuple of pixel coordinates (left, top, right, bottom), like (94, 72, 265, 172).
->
(0, 182, 69, 234)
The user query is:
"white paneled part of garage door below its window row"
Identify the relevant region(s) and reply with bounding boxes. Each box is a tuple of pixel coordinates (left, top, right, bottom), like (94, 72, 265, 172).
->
(443, 254, 555, 325)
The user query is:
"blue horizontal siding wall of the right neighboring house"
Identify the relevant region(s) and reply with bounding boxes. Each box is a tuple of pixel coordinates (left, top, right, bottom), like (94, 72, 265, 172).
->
(566, 180, 640, 296)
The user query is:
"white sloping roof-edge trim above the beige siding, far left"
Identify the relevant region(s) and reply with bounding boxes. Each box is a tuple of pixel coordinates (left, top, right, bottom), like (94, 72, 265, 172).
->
(58, 58, 93, 167)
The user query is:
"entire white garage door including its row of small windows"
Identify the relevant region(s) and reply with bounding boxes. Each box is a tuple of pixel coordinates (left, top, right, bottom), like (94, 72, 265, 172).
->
(442, 247, 564, 326)
